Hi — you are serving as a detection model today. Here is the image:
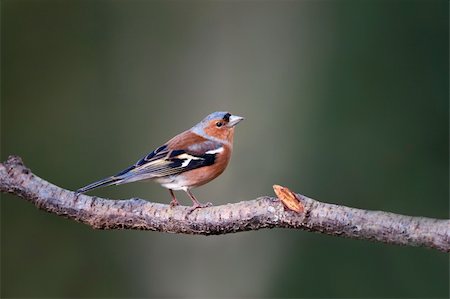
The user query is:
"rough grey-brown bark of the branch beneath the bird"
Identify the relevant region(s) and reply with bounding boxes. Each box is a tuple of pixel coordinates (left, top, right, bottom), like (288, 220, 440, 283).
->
(0, 156, 450, 252)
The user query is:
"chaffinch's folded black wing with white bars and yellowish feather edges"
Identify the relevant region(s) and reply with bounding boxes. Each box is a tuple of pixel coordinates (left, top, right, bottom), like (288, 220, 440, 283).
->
(115, 140, 223, 182)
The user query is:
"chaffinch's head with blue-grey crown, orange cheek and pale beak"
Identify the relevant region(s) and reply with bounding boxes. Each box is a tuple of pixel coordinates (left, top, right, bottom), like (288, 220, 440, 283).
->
(193, 112, 244, 142)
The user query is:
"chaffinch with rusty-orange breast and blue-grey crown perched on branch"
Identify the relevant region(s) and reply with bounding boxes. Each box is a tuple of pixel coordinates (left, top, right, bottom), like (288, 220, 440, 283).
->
(76, 112, 244, 211)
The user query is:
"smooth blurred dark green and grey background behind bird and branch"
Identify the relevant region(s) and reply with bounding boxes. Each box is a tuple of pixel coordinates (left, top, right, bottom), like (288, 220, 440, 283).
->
(0, 0, 449, 298)
